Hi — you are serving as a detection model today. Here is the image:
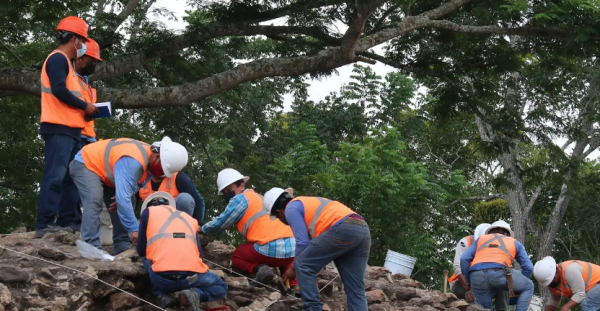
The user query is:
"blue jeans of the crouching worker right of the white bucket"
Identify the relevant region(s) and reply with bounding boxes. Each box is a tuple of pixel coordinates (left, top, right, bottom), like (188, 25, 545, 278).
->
(471, 269, 533, 311)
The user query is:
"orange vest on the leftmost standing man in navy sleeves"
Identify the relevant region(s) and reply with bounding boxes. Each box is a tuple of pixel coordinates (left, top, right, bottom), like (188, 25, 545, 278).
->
(40, 50, 86, 128)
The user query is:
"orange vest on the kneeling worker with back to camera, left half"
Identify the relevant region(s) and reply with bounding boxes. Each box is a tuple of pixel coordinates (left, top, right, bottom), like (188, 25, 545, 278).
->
(146, 205, 208, 273)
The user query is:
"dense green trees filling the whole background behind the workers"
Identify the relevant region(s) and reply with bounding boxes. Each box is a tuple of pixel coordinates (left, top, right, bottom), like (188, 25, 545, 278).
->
(0, 0, 600, 286)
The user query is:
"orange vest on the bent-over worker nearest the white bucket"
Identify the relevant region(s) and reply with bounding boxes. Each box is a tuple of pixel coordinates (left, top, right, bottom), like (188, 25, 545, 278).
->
(291, 197, 356, 239)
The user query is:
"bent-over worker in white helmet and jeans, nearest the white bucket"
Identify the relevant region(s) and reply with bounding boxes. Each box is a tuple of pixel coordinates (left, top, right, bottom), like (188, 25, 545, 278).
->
(263, 188, 371, 311)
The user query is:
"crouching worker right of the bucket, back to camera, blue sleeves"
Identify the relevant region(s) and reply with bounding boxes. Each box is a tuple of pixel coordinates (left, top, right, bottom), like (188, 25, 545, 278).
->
(460, 220, 534, 311)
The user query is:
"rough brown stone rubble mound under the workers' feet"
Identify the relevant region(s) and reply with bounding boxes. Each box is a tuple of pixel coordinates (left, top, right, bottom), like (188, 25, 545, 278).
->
(0, 230, 482, 311)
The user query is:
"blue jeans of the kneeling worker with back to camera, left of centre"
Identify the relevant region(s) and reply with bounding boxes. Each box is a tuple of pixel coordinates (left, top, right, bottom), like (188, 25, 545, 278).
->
(142, 254, 227, 302)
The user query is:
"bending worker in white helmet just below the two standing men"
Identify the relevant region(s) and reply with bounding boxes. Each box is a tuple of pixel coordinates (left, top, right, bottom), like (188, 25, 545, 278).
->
(69, 137, 188, 255)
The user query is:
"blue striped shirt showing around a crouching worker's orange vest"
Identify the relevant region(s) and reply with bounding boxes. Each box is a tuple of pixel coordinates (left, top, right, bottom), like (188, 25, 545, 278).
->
(202, 190, 296, 258)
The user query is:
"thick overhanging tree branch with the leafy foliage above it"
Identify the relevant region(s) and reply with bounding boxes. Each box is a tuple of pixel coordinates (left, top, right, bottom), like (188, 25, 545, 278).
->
(0, 0, 600, 108)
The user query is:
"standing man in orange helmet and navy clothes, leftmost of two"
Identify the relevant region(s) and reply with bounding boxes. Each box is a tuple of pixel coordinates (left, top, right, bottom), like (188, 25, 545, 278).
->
(35, 16, 98, 238)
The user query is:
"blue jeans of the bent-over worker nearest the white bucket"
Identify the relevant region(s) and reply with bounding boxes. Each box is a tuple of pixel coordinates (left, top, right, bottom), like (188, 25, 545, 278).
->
(294, 220, 371, 311)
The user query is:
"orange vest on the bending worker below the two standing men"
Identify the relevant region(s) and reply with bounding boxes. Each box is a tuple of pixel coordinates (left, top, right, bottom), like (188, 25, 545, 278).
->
(81, 138, 152, 188)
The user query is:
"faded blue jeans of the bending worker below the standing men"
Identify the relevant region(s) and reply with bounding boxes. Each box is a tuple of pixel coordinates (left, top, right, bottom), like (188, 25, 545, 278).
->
(69, 160, 133, 255)
